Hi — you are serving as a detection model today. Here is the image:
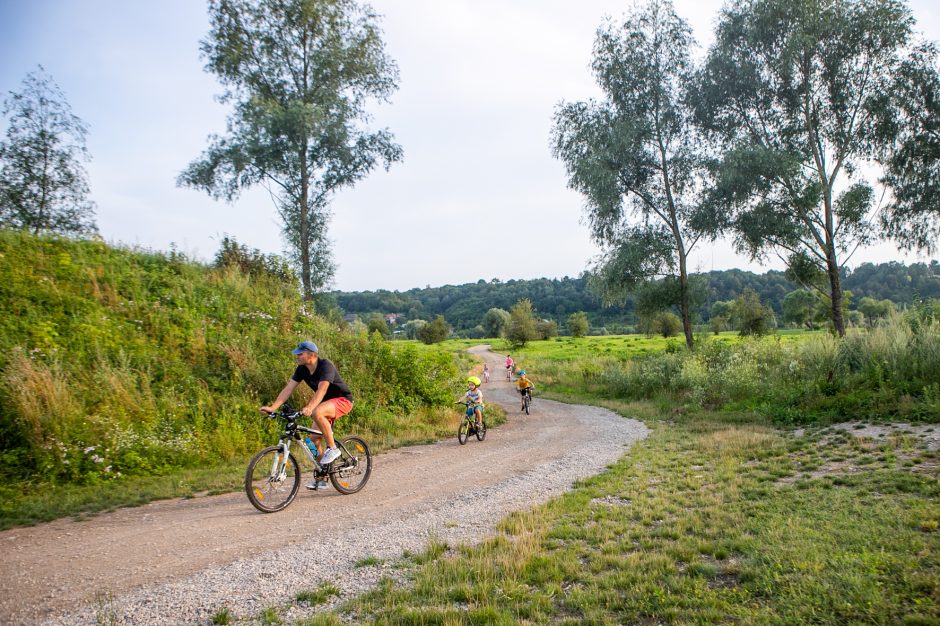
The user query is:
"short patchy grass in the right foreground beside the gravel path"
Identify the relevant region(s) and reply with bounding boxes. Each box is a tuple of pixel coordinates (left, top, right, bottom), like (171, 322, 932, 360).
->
(320, 405, 940, 625)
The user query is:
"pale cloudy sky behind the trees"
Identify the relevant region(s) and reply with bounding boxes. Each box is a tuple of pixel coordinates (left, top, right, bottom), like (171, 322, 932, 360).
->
(0, 0, 940, 291)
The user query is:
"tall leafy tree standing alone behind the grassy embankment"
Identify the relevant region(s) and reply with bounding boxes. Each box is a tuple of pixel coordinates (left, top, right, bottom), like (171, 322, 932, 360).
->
(177, 0, 402, 300)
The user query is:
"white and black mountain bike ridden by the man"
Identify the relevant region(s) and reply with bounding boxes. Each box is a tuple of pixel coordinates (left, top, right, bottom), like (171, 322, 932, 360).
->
(245, 404, 372, 513)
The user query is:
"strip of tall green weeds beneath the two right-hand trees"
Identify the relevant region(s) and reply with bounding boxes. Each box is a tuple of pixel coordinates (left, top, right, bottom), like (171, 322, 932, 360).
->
(524, 307, 940, 423)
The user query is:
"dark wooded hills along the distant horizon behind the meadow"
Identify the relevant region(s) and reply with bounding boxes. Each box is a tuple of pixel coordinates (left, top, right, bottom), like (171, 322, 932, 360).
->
(331, 260, 940, 333)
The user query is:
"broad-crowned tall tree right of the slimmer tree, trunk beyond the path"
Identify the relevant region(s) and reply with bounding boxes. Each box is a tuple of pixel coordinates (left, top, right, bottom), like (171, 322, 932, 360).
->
(696, 0, 936, 335)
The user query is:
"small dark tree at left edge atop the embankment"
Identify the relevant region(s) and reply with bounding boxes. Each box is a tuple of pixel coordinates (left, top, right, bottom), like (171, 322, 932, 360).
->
(0, 66, 97, 234)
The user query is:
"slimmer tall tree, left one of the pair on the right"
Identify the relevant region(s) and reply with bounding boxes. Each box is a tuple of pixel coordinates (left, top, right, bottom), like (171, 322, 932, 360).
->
(552, 0, 707, 348)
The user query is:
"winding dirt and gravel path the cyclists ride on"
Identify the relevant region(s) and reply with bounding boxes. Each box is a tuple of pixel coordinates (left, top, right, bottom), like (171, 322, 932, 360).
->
(0, 346, 646, 624)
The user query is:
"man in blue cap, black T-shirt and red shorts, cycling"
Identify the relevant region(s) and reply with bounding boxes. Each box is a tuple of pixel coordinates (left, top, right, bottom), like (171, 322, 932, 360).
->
(261, 341, 353, 489)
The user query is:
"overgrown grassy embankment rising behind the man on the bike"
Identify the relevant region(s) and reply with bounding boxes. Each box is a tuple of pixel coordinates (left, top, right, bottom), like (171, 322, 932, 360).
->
(0, 231, 460, 484)
